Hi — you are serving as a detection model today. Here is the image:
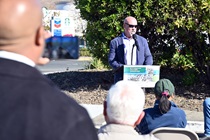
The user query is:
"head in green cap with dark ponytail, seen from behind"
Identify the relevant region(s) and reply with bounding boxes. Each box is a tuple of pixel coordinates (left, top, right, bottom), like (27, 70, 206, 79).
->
(154, 79, 175, 114)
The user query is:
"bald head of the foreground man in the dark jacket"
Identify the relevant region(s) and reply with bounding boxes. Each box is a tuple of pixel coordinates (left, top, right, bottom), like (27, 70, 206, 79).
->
(0, 0, 42, 46)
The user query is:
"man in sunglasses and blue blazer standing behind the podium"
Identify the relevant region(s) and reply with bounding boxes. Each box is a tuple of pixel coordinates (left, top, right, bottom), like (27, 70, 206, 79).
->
(108, 16, 153, 83)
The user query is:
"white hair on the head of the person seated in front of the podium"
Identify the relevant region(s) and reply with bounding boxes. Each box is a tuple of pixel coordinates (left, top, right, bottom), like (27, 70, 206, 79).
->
(106, 81, 145, 125)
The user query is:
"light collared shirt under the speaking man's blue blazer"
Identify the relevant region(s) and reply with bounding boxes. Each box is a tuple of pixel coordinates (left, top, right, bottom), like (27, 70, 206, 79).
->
(122, 33, 136, 65)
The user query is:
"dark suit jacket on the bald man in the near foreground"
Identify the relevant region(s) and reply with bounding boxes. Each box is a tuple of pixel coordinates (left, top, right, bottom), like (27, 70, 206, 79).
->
(0, 58, 98, 140)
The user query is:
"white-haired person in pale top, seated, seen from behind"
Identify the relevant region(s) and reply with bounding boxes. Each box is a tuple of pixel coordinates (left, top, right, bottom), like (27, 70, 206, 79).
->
(98, 81, 157, 140)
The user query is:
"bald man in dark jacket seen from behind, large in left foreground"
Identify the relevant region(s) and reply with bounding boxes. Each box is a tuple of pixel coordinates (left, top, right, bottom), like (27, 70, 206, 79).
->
(0, 0, 98, 140)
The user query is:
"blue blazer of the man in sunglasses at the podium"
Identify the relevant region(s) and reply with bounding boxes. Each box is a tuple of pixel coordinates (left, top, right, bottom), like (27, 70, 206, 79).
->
(108, 34, 153, 83)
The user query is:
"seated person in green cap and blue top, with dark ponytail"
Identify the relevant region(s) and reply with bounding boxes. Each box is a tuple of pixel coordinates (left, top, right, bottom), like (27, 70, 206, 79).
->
(137, 79, 187, 134)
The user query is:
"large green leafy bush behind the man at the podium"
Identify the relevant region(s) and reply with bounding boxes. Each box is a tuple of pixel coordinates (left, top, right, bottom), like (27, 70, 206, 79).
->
(75, 0, 210, 81)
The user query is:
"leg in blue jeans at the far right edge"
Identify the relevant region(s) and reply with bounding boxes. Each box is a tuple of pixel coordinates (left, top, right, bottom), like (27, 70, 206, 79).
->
(200, 98, 210, 140)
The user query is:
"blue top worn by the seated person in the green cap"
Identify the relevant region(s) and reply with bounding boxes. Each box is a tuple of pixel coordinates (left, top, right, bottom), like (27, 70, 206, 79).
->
(137, 100, 187, 134)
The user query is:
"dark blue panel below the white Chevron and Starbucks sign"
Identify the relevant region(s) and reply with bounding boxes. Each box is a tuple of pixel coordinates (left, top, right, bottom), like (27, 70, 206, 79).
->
(44, 36, 79, 59)
